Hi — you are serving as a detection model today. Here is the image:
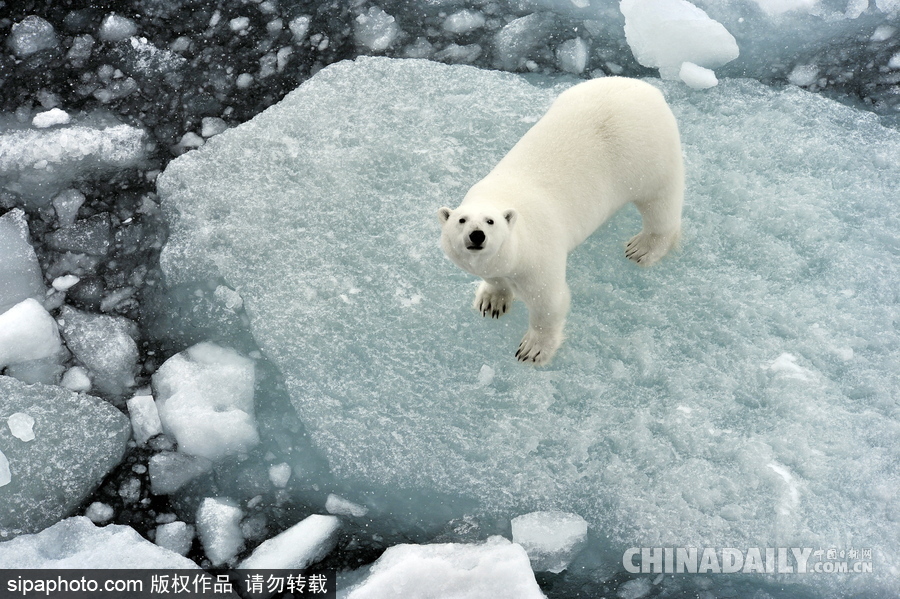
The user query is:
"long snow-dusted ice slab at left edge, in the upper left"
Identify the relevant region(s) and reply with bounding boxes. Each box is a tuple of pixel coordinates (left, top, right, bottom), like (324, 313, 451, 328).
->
(0, 119, 146, 205)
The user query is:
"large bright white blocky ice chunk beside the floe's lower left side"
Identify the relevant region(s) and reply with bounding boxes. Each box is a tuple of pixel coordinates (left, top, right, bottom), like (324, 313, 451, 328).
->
(153, 343, 259, 461)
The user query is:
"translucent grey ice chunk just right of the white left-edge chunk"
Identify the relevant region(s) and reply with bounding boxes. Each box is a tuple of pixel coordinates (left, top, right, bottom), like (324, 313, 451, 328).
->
(60, 306, 138, 397)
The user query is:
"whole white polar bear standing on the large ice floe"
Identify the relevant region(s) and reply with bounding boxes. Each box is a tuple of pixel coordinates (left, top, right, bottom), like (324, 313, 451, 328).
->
(438, 77, 684, 365)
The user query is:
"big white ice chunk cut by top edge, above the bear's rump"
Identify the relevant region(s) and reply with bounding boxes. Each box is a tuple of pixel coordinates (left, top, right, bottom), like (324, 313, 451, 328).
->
(620, 0, 740, 79)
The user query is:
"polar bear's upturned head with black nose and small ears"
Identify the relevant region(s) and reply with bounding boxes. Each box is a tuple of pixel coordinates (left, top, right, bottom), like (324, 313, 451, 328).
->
(438, 205, 518, 274)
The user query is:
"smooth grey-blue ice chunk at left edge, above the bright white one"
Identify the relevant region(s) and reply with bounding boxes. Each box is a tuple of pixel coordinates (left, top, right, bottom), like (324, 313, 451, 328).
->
(0, 209, 45, 314)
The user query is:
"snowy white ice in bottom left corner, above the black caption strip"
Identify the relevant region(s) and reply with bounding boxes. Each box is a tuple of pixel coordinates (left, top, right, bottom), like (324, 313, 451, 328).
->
(0, 516, 198, 570)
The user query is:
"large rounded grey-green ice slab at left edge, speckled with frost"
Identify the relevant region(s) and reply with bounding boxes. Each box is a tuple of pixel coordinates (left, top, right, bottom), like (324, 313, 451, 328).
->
(0, 376, 131, 540)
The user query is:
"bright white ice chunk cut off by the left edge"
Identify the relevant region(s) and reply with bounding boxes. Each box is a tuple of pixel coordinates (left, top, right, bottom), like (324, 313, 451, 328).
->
(0, 298, 61, 370)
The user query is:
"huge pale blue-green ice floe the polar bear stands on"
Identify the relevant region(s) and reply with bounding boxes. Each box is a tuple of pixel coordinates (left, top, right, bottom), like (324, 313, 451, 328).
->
(159, 58, 900, 595)
